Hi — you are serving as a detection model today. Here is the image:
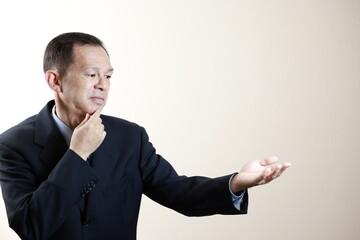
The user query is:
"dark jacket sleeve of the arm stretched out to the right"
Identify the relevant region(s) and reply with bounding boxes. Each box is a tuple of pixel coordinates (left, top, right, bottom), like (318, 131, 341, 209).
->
(140, 126, 248, 216)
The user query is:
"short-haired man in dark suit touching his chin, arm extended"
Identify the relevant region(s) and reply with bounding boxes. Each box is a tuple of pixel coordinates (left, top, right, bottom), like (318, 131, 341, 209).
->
(0, 33, 290, 240)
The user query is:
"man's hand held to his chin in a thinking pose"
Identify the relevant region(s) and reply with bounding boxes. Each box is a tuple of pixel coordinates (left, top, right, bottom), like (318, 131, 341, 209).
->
(70, 109, 106, 161)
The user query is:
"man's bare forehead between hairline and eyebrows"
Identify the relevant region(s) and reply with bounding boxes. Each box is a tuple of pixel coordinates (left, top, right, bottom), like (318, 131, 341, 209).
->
(73, 44, 111, 69)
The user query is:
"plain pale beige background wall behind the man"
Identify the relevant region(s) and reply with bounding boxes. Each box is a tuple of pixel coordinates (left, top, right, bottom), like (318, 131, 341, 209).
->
(0, 0, 360, 240)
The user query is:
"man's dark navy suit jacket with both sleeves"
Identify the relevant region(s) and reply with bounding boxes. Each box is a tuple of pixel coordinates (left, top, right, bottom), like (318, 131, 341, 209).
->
(0, 101, 248, 240)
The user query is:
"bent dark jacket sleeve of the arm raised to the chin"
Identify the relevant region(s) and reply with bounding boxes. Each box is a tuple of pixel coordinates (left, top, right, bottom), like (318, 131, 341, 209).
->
(0, 144, 99, 240)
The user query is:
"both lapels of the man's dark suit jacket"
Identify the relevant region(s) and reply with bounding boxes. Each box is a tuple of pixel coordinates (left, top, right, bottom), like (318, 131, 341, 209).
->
(34, 101, 124, 215)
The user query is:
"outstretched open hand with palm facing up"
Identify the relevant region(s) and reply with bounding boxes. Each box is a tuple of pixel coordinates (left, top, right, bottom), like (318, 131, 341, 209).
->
(230, 157, 291, 193)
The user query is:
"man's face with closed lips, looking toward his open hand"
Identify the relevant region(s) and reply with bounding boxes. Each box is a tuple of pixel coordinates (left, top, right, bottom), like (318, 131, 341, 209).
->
(60, 45, 113, 116)
